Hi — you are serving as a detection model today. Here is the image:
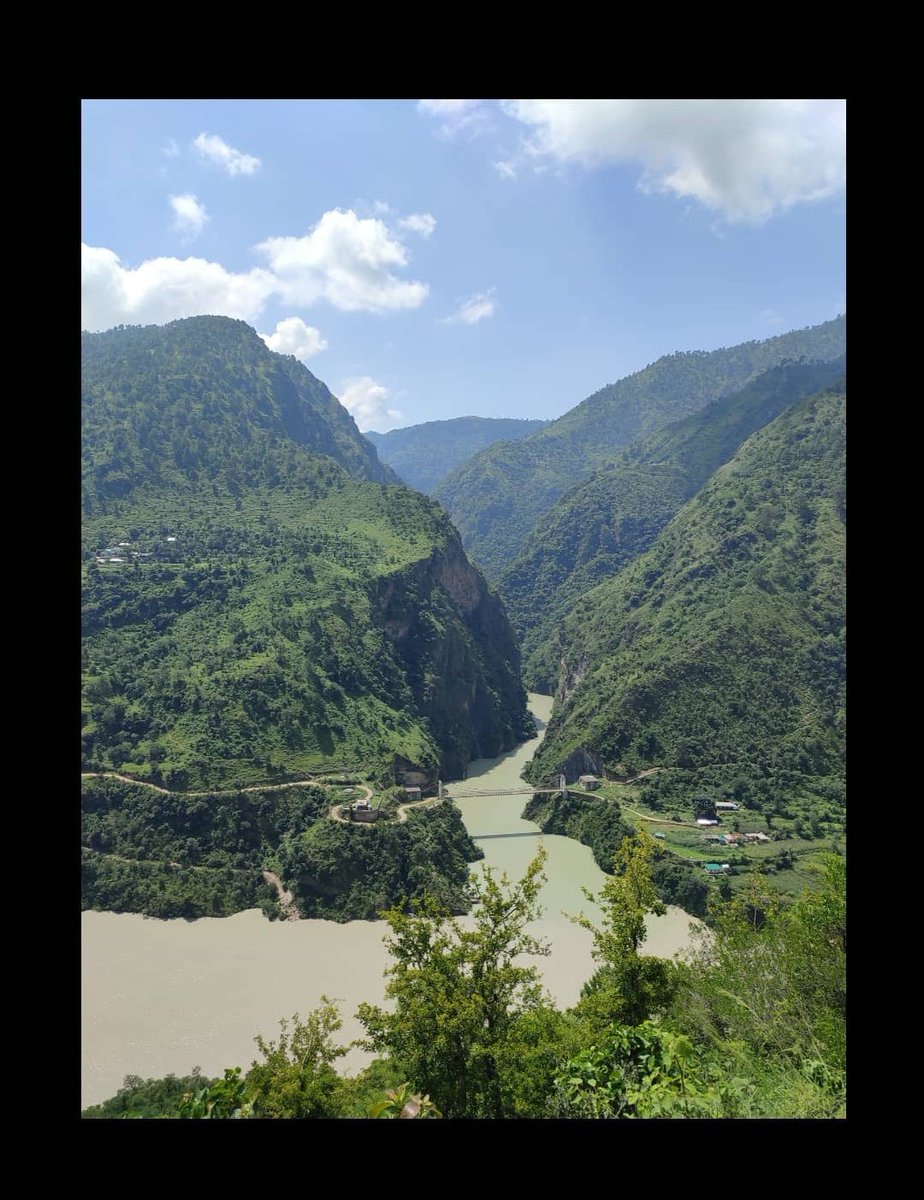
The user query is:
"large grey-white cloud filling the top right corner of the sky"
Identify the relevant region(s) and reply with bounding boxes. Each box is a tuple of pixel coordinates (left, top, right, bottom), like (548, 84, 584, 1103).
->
(503, 100, 846, 224)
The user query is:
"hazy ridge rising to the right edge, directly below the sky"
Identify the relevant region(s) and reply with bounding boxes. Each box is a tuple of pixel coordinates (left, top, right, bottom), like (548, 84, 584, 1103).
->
(433, 317, 847, 580)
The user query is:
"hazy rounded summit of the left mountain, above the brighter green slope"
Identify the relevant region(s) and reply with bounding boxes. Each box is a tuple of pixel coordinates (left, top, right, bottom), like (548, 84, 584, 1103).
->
(80, 317, 396, 504)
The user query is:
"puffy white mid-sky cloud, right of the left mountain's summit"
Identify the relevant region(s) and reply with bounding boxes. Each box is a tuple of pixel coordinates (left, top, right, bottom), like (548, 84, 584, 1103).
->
(256, 209, 430, 312)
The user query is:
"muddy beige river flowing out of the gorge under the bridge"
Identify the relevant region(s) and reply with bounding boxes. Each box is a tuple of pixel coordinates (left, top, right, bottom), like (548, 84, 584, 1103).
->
(82, 695, 692, 1106)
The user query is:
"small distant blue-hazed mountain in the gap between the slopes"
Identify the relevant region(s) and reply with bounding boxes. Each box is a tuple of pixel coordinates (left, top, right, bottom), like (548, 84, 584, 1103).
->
(366, 416, 548, 493)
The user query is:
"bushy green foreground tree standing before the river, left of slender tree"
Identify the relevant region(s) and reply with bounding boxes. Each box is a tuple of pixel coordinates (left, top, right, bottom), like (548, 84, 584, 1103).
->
(359, 851, 548, 1117)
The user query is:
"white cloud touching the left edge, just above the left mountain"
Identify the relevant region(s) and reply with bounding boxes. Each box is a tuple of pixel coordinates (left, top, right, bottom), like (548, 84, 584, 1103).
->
(80, 246, 277, 330)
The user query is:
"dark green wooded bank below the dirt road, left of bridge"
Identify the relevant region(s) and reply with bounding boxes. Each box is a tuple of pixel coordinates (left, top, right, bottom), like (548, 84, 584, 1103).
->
(80, 778, 481, 920)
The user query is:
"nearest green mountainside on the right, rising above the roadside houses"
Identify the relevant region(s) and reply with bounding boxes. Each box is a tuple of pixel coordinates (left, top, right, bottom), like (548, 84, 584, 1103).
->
(529, 384, 846, 814)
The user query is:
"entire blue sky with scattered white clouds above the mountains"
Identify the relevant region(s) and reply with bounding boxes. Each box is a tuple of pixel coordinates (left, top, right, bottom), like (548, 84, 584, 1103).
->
(82, 100, 846, 432)
